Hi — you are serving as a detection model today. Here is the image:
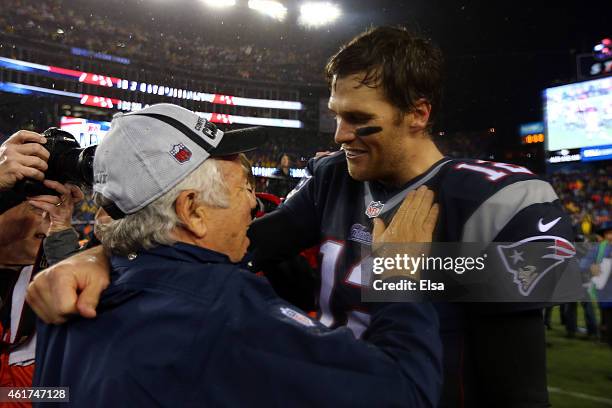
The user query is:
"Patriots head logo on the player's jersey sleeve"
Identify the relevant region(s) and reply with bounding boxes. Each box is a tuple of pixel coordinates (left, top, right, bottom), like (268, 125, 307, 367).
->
(497, 235, 576, 296)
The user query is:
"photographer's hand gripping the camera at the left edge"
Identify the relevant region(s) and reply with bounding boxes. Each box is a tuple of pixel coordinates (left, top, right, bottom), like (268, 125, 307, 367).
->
(0, 130, 49, 191)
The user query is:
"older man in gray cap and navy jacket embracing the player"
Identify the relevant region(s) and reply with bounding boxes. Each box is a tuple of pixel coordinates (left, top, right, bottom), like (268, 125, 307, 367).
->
(35, 104, 441, 407)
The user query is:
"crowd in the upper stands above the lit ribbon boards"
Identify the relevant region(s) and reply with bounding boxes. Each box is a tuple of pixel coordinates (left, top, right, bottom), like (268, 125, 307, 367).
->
(0, 0, 326, 83)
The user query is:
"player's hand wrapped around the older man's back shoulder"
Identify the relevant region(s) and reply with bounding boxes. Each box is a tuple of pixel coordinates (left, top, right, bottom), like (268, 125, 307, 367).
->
(26, 245, 110, 324)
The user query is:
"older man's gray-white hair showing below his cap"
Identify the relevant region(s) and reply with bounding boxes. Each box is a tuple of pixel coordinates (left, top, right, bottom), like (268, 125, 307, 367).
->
(95, 159, 229, 256)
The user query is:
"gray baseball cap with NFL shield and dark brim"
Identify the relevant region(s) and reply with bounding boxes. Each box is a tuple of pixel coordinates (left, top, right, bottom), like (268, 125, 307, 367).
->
(93, 103, 266, 219)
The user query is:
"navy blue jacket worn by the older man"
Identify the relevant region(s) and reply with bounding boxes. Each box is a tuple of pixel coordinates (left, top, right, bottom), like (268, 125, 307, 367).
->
(34, 243, 442, 407)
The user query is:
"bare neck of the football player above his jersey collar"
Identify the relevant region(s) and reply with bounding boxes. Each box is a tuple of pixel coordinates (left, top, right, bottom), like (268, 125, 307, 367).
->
(379, 138, 444, 187)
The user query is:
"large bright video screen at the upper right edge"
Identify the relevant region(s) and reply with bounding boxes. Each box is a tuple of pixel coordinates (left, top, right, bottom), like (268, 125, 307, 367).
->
(544, 77, 612, 155)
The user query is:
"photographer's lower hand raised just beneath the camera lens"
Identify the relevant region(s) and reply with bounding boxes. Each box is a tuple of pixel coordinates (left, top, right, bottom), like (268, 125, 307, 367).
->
(28, 180, 85, 236)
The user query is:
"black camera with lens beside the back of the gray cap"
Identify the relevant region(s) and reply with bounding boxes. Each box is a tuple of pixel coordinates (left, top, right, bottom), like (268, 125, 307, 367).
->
(13, 127, 97, 197)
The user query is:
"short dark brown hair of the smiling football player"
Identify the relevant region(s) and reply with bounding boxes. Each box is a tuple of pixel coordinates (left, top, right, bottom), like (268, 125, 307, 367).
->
(325, 27, 443, 131)
